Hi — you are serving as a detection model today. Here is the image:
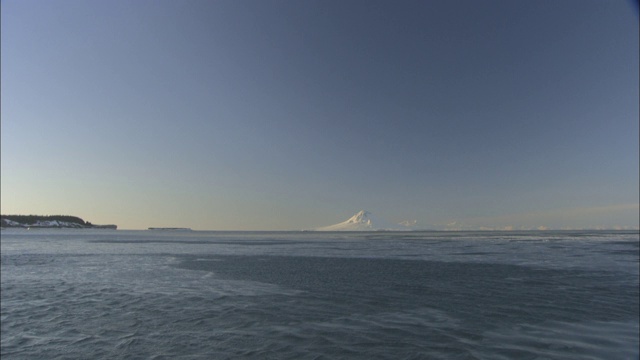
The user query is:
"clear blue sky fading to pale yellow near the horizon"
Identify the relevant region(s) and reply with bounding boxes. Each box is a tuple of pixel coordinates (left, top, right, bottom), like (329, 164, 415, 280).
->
(0, 0, 640, 230)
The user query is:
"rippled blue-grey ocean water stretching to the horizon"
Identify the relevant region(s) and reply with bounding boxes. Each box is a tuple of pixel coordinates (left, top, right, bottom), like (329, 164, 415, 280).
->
(0, 229, 640, 359)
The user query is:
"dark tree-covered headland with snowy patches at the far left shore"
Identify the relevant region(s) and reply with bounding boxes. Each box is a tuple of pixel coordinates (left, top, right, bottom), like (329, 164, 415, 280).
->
(0, 215, 118, 229)
